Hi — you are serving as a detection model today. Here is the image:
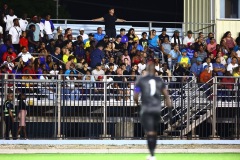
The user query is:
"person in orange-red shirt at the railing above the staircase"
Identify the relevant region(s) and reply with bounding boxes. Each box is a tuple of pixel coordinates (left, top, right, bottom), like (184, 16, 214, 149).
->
(200, 65, 212, 97)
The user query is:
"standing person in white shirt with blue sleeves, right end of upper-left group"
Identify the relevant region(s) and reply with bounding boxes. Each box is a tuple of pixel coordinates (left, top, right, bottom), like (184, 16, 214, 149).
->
(41, 14, 54, 39)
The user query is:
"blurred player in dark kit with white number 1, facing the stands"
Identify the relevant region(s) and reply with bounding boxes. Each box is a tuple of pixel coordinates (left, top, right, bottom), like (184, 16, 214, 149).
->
(134, 63, 172, 160)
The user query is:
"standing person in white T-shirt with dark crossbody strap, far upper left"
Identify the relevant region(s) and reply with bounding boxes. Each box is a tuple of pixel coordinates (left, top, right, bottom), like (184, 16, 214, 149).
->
(9, 18, 22, 53)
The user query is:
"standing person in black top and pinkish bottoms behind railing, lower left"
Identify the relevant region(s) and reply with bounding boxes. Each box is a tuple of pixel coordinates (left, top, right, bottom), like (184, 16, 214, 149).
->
(17, 94, 27, 140)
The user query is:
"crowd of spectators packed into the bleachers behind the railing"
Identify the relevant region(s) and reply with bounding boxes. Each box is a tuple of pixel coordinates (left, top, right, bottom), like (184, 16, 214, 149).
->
(0, 4, 240, 99)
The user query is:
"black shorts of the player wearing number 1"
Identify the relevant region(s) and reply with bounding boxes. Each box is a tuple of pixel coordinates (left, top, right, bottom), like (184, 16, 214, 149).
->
(141, 112, 160, 132)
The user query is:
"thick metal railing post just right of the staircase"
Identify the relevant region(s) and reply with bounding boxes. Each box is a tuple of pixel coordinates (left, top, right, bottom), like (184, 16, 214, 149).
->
(212, 77, 217, 139)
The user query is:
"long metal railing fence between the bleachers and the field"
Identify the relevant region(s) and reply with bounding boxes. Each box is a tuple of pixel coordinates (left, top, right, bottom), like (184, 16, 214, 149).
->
(0, 75, 240, 139)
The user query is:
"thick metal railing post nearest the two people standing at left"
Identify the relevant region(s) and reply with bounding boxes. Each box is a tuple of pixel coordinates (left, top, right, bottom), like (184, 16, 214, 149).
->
(55, 75, 62, 138)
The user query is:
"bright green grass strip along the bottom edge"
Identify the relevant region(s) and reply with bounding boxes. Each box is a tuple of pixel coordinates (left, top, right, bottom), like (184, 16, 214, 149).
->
(0, 153, 240, 160)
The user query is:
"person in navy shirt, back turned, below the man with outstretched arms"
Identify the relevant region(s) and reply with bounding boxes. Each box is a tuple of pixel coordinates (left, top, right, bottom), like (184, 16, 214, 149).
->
(90, 45, 104, 68)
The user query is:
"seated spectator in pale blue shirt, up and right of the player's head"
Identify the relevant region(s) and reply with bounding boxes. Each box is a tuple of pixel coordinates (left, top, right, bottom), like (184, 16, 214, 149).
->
(168, 44, 181, 70)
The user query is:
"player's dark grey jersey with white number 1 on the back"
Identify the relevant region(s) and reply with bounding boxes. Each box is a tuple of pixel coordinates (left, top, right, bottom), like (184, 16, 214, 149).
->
(135, 75, 166, 109)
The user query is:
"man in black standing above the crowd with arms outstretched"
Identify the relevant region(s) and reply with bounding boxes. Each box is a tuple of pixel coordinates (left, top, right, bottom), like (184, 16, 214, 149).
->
(93, 8, 125, 38)
